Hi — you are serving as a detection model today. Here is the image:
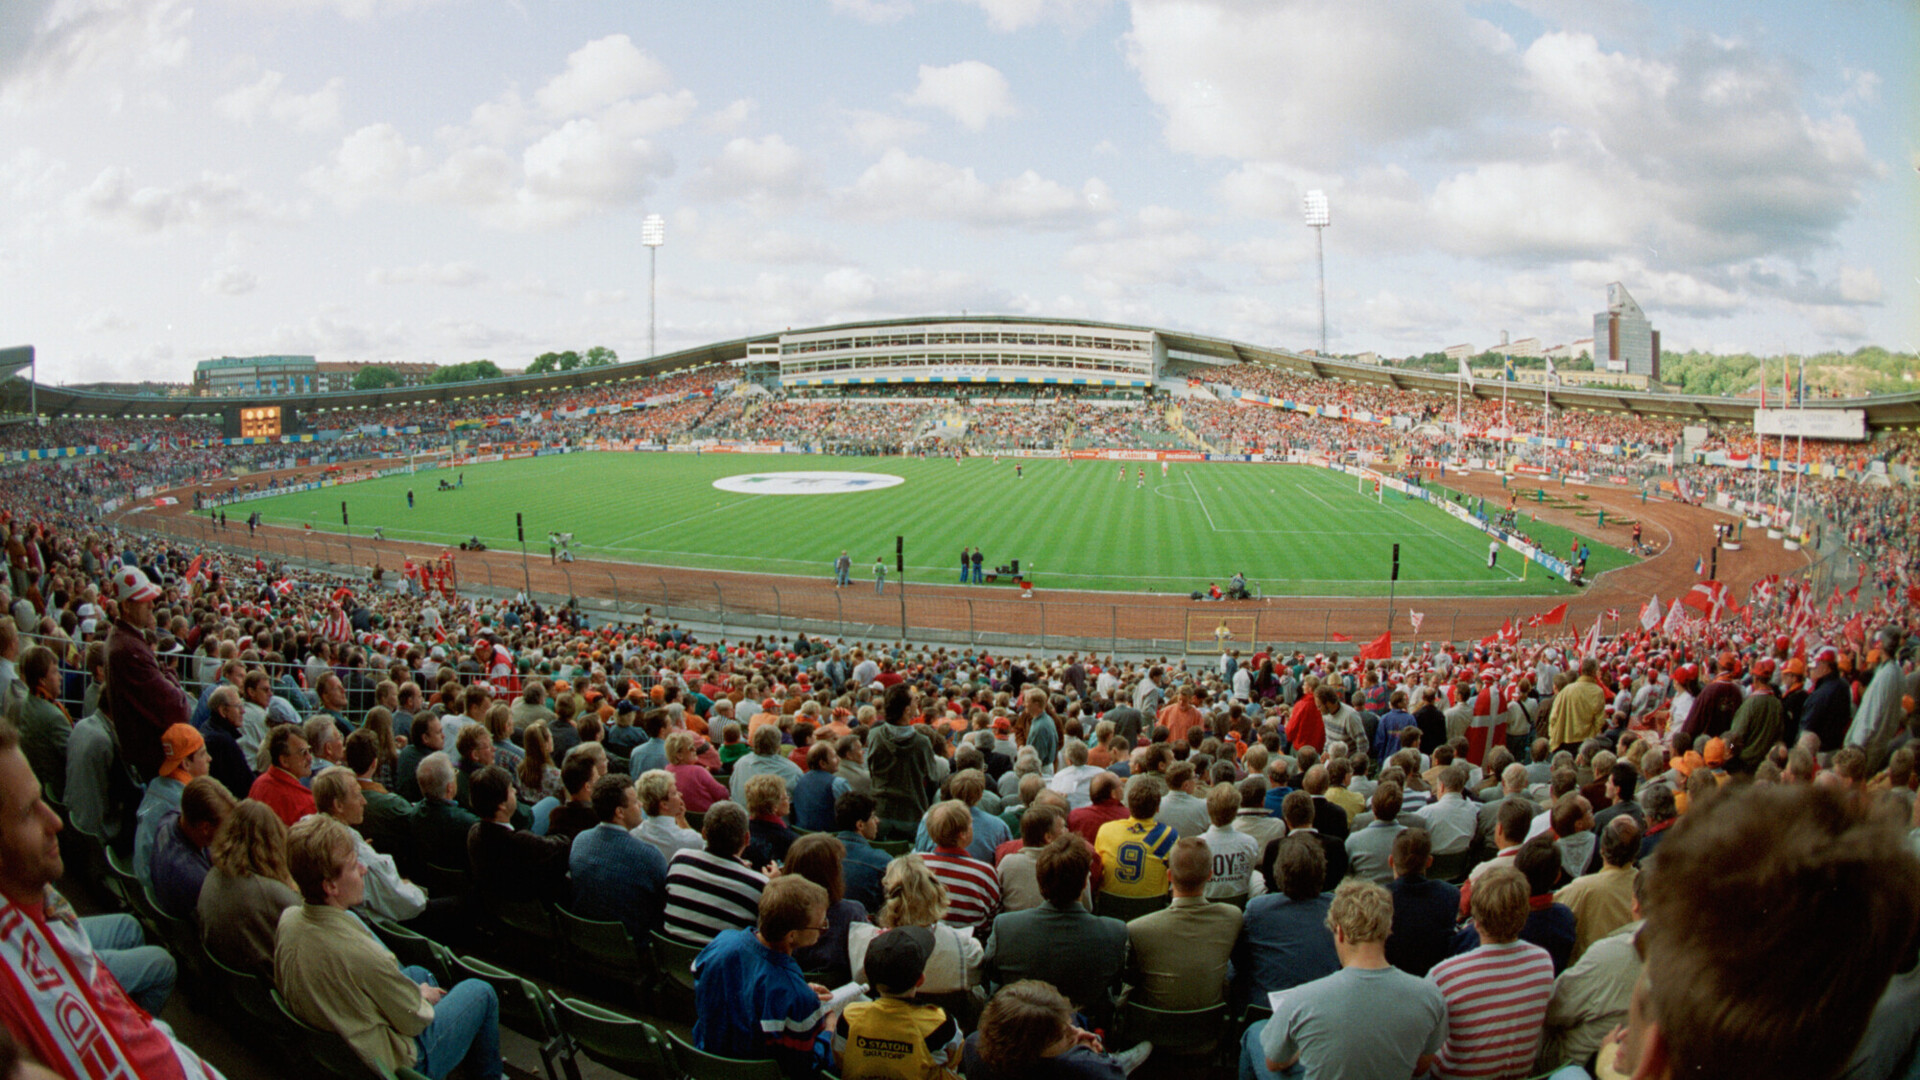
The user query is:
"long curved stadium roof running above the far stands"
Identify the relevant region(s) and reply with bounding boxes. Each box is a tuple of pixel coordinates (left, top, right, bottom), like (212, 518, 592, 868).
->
(0, 315, 1920, 430)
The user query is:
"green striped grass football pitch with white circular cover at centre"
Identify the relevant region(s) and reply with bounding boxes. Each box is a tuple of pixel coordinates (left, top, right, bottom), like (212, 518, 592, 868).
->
(228, 452, 1634, 598)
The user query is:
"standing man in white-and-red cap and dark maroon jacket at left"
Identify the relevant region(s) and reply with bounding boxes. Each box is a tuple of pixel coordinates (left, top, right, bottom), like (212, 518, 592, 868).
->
(106, 567, 194, 780)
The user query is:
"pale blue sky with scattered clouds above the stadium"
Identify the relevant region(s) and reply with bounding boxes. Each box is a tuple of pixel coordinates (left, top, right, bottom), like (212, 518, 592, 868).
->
(0, 0, 1920, 382)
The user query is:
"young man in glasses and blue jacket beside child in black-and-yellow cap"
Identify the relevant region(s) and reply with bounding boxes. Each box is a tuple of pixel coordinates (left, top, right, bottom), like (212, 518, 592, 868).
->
(693, 874, 831, 1076)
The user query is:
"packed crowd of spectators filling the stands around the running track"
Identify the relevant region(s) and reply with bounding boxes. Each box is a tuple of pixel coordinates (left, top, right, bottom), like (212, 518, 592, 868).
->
(0, 322, 1920, 1080)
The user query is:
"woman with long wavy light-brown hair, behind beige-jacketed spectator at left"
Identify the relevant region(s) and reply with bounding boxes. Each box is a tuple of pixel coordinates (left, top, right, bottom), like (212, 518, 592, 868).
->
(196, 799, 300, 980)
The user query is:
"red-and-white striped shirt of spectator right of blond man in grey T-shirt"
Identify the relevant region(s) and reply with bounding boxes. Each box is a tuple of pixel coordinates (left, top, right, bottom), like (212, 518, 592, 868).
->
(1427, 942, 1553, 1080)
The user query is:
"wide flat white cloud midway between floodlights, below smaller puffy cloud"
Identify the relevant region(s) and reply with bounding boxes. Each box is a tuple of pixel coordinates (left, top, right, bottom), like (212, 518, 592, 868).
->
(837, 150, 1112, 229)
